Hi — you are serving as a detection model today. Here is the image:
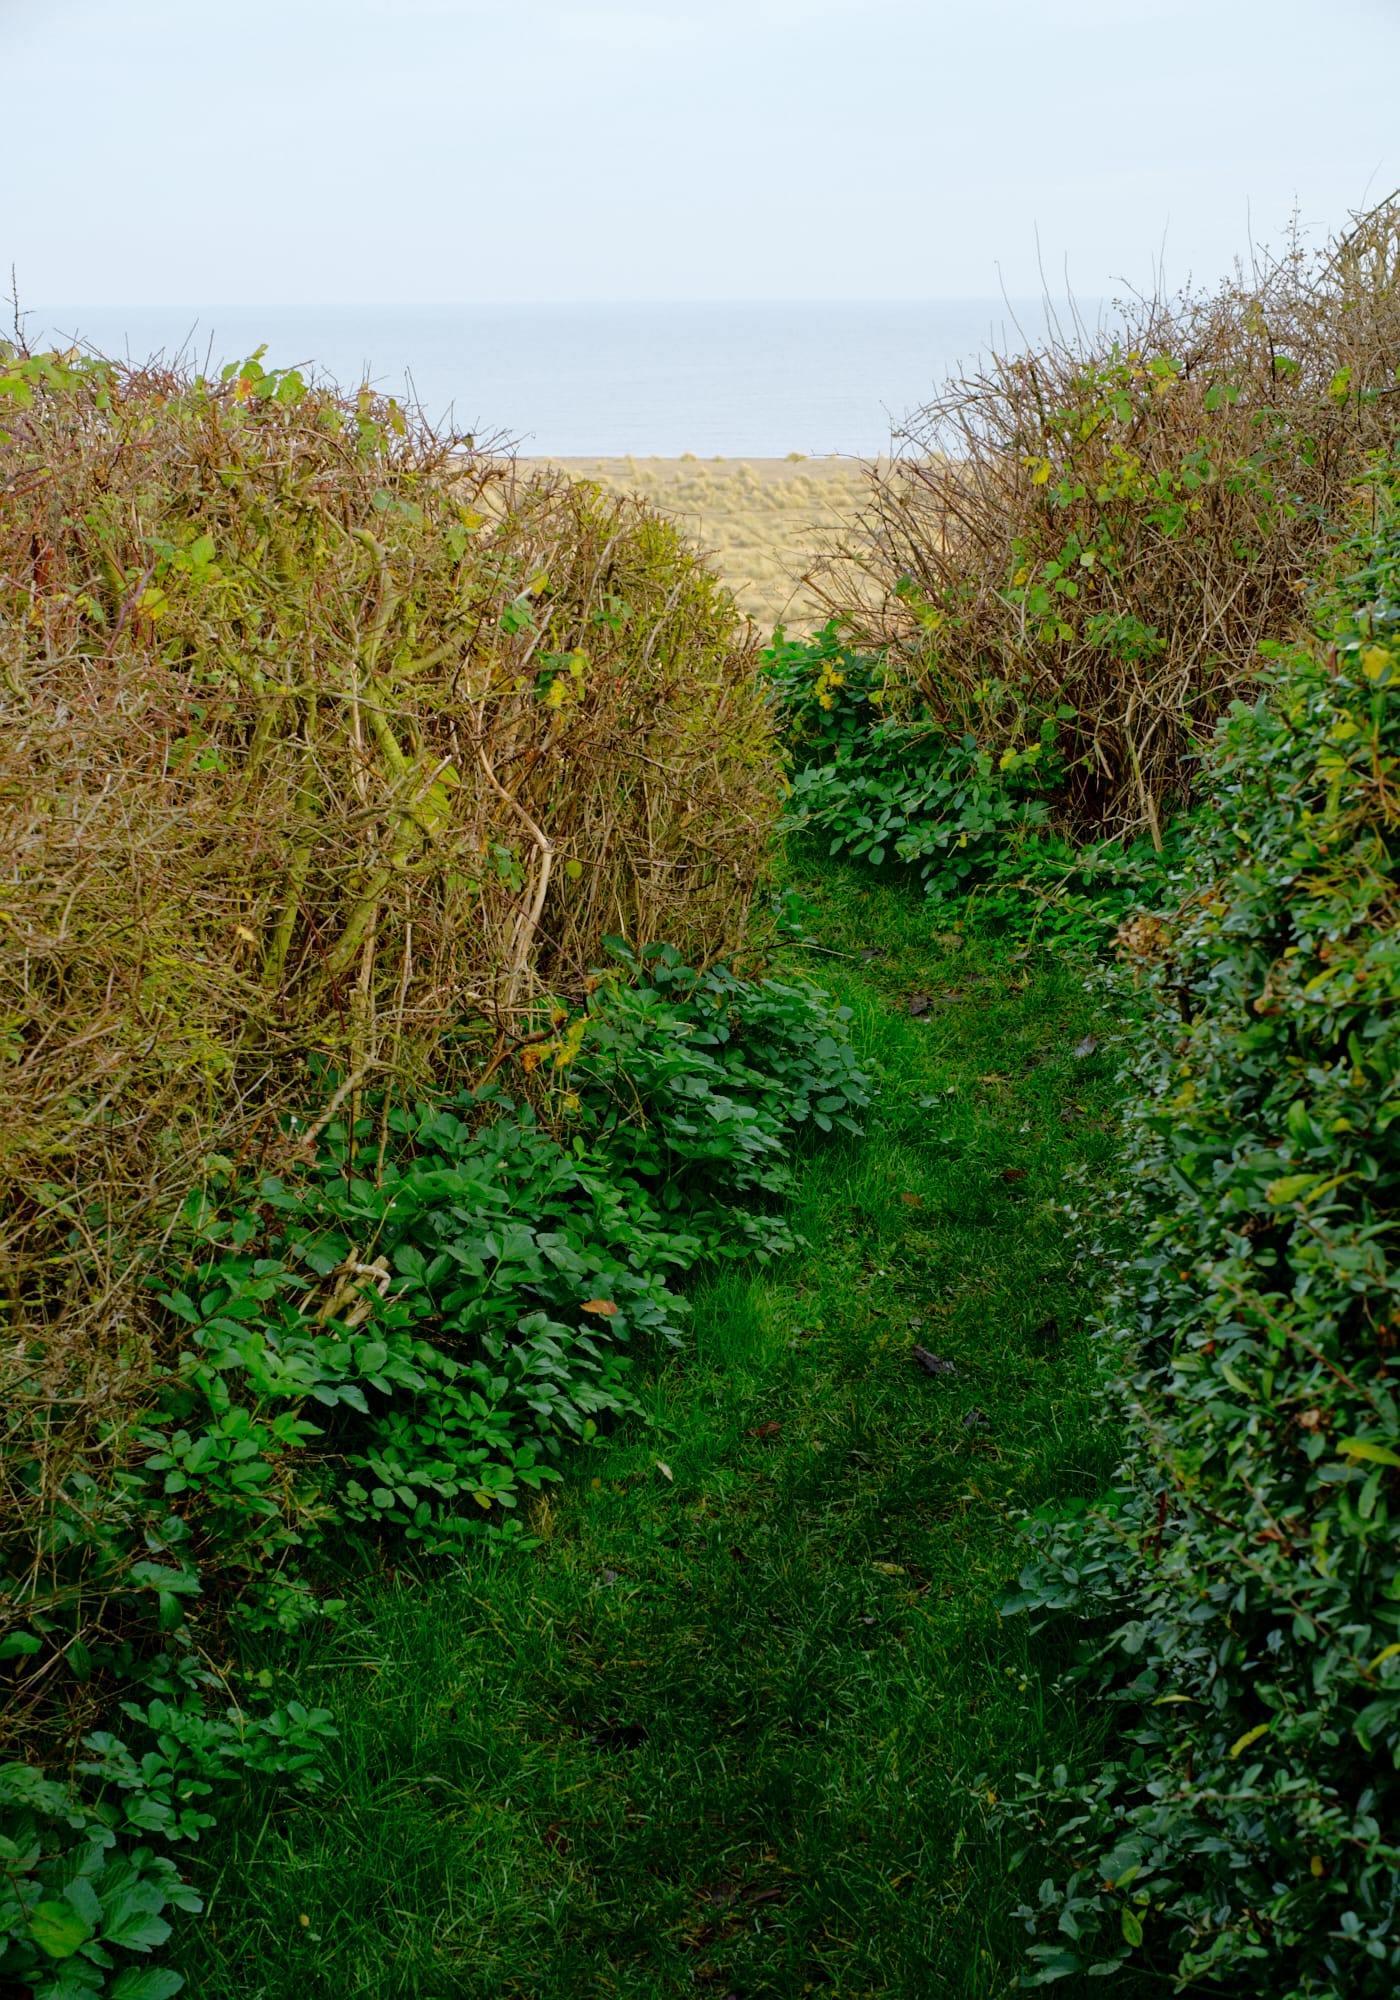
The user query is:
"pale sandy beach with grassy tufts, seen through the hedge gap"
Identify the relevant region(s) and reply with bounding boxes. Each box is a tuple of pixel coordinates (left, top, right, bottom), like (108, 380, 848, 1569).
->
(524, 452, 866, 636)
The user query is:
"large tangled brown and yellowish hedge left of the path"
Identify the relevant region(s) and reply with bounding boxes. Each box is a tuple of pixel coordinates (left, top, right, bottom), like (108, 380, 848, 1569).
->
(0, 350, 778, 1704)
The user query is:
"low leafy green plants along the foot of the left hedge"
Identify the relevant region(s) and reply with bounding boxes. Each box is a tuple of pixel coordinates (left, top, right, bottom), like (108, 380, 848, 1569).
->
(0, 944, 868, 2000)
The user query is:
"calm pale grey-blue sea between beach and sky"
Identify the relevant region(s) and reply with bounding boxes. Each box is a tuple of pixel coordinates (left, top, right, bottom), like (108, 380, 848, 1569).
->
(28, 298, 1096, 458)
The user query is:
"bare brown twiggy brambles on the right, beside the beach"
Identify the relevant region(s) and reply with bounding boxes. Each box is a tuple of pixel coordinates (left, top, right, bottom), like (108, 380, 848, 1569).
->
(814, 200, 1400, 842)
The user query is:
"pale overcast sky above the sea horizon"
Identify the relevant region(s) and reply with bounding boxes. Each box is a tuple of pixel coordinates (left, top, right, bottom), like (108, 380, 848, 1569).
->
(0, 0, 1400, 304)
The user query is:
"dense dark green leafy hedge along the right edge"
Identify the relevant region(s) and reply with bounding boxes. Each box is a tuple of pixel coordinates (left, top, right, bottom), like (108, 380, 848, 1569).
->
(1010, 486, 1400, 2000)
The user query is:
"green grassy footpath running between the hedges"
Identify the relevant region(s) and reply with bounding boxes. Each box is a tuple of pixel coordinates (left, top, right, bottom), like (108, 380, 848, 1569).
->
(186, 874, 1136, 2000)
